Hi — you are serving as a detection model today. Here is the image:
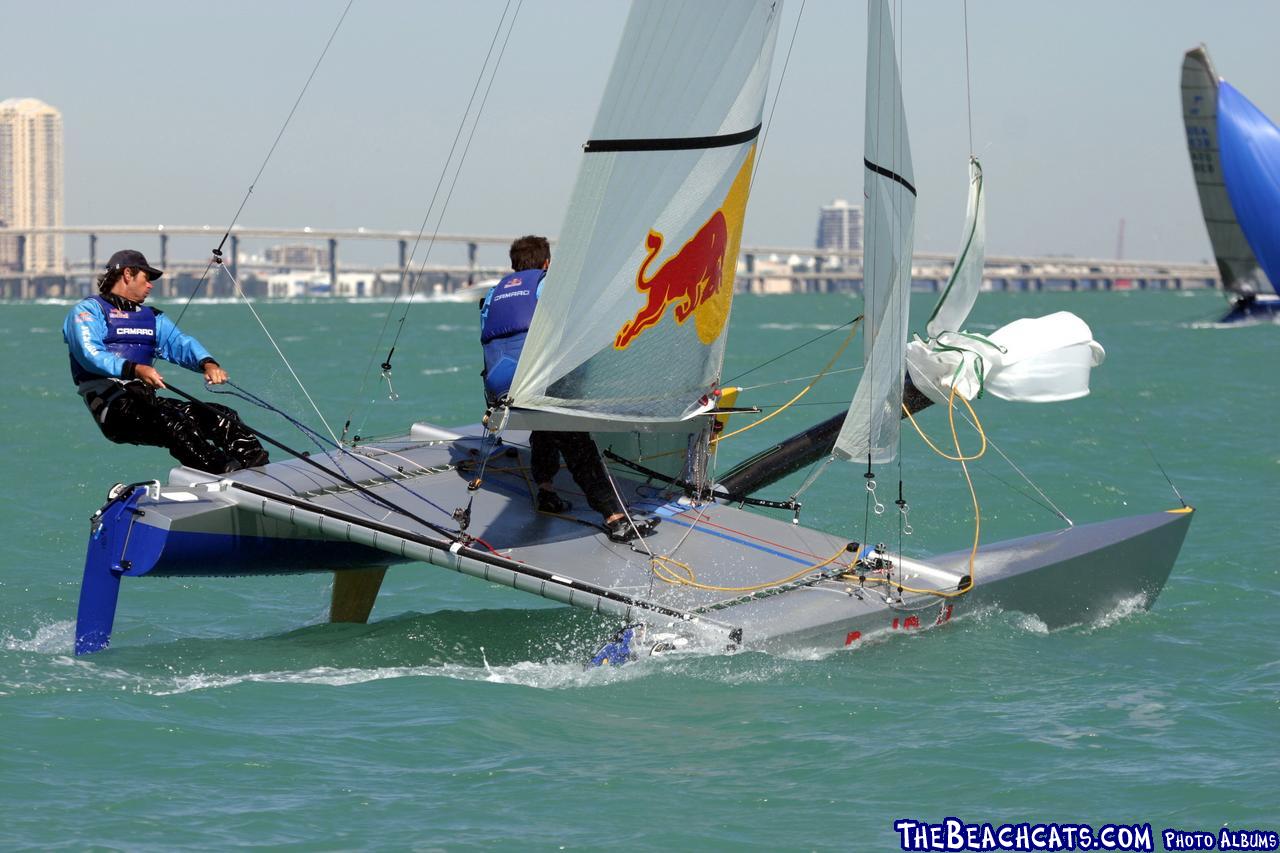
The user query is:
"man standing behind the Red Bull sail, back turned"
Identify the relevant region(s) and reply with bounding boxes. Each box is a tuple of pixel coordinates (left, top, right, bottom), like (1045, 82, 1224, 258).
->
(480, 234, 650, 542)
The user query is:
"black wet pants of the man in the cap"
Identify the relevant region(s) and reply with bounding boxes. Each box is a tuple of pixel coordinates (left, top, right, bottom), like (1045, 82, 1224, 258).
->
(84, 382, 268, 474)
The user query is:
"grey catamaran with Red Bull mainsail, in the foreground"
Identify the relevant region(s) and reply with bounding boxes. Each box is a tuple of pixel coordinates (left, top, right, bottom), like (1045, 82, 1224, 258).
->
(76, 0, 1192, 662)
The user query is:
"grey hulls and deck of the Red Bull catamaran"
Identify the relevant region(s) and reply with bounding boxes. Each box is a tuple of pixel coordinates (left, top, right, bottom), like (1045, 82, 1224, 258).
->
(76, 425, 1192, 653)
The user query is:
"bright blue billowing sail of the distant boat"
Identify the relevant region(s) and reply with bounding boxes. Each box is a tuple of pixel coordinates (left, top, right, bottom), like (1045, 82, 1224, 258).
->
(1217, 81, 1280, 292)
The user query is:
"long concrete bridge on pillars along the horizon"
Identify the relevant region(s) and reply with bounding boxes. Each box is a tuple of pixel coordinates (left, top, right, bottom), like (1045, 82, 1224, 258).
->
(0, 225, 1221, 300)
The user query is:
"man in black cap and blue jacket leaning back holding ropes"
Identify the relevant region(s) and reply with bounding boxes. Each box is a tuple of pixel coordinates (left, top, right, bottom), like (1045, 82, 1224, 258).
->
(63, 248, 268, 474)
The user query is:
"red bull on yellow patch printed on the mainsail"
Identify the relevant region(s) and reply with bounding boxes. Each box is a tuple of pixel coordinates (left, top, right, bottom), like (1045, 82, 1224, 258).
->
(613, 146, 755, 350)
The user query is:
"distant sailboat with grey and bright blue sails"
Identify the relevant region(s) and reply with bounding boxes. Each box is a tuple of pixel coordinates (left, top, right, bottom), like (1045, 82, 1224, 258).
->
(1181, 45, 1280, 323)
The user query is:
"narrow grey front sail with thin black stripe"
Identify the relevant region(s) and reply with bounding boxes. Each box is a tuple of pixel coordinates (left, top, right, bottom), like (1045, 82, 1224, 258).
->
(835, 0, 915, 462)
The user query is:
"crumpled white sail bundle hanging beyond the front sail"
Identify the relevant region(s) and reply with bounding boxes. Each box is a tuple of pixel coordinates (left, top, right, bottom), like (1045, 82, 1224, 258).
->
(906, 159, 1106, 403)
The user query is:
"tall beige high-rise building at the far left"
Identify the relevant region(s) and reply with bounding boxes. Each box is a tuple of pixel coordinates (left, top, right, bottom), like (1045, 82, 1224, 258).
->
(0, 97, 63, 273)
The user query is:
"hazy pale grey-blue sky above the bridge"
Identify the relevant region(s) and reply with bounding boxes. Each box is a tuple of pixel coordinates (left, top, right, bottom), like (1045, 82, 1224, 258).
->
(0, 0, 1280, 263)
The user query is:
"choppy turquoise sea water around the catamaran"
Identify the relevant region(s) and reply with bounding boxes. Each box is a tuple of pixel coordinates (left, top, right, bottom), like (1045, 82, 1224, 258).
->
(0, 293, 1280, 850)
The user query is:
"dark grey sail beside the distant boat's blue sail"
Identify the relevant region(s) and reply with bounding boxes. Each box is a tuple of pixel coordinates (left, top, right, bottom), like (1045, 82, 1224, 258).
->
(1183, 45, 1271, 298)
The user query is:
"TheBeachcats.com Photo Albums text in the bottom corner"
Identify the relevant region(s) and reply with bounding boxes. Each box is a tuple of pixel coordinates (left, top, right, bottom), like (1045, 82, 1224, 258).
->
(893, 817, 1280, 853)
